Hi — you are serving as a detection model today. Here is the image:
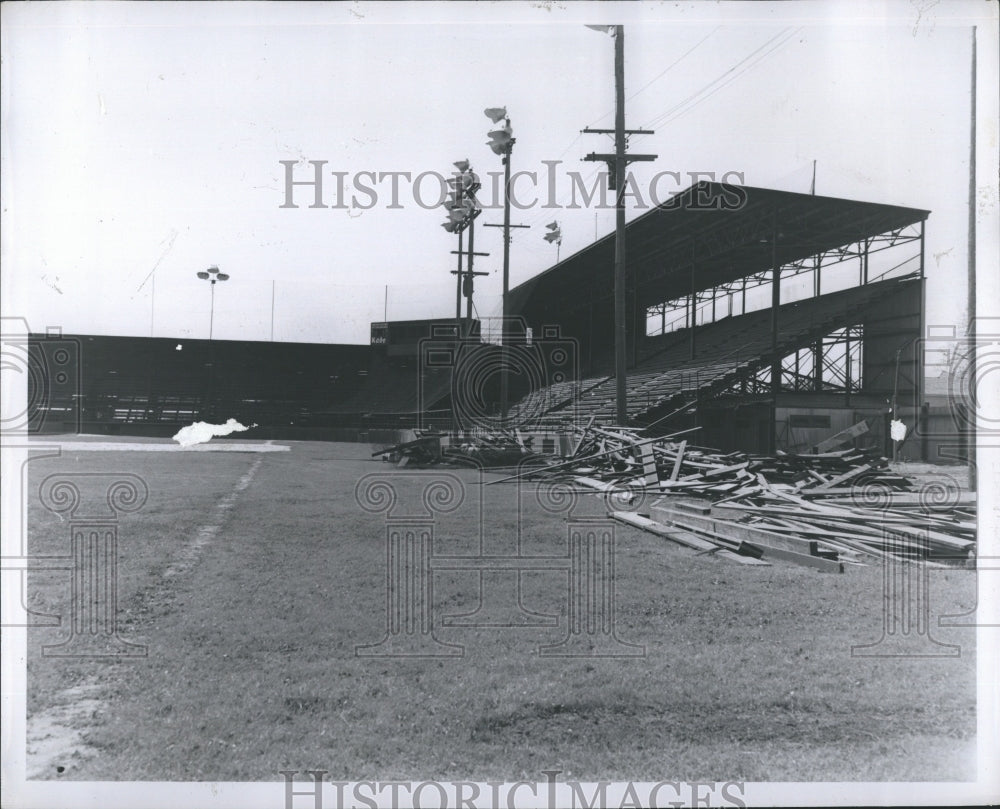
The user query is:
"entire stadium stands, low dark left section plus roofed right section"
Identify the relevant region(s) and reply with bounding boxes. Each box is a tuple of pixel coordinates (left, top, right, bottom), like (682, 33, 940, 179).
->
(23, 183, 944, 457)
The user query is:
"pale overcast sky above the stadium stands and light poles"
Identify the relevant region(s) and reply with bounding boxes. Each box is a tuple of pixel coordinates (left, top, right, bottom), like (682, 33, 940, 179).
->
(2, 2, 997, 343)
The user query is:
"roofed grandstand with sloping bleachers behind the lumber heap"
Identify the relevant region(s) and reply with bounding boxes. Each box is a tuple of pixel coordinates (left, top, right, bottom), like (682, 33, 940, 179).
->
(511, 183, 929, 457)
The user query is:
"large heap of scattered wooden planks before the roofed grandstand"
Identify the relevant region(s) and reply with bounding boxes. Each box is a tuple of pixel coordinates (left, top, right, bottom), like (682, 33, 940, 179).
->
(497, 423, 976, 566)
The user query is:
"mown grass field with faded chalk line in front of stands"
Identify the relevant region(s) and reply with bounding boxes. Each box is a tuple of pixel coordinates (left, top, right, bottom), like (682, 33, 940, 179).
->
(28, 442, 976, 781)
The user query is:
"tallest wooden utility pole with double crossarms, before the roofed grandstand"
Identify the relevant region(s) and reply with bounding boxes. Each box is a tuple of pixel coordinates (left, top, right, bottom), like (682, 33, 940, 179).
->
(583, 25, 656, 427)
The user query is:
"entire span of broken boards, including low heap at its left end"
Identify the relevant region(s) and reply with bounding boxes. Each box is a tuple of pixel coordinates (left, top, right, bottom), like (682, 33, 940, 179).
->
(372, 419, 976, 572)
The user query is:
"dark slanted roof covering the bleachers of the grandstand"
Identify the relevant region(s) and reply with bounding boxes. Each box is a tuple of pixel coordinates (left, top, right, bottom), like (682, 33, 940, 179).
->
(509, 182, 930, 320)
